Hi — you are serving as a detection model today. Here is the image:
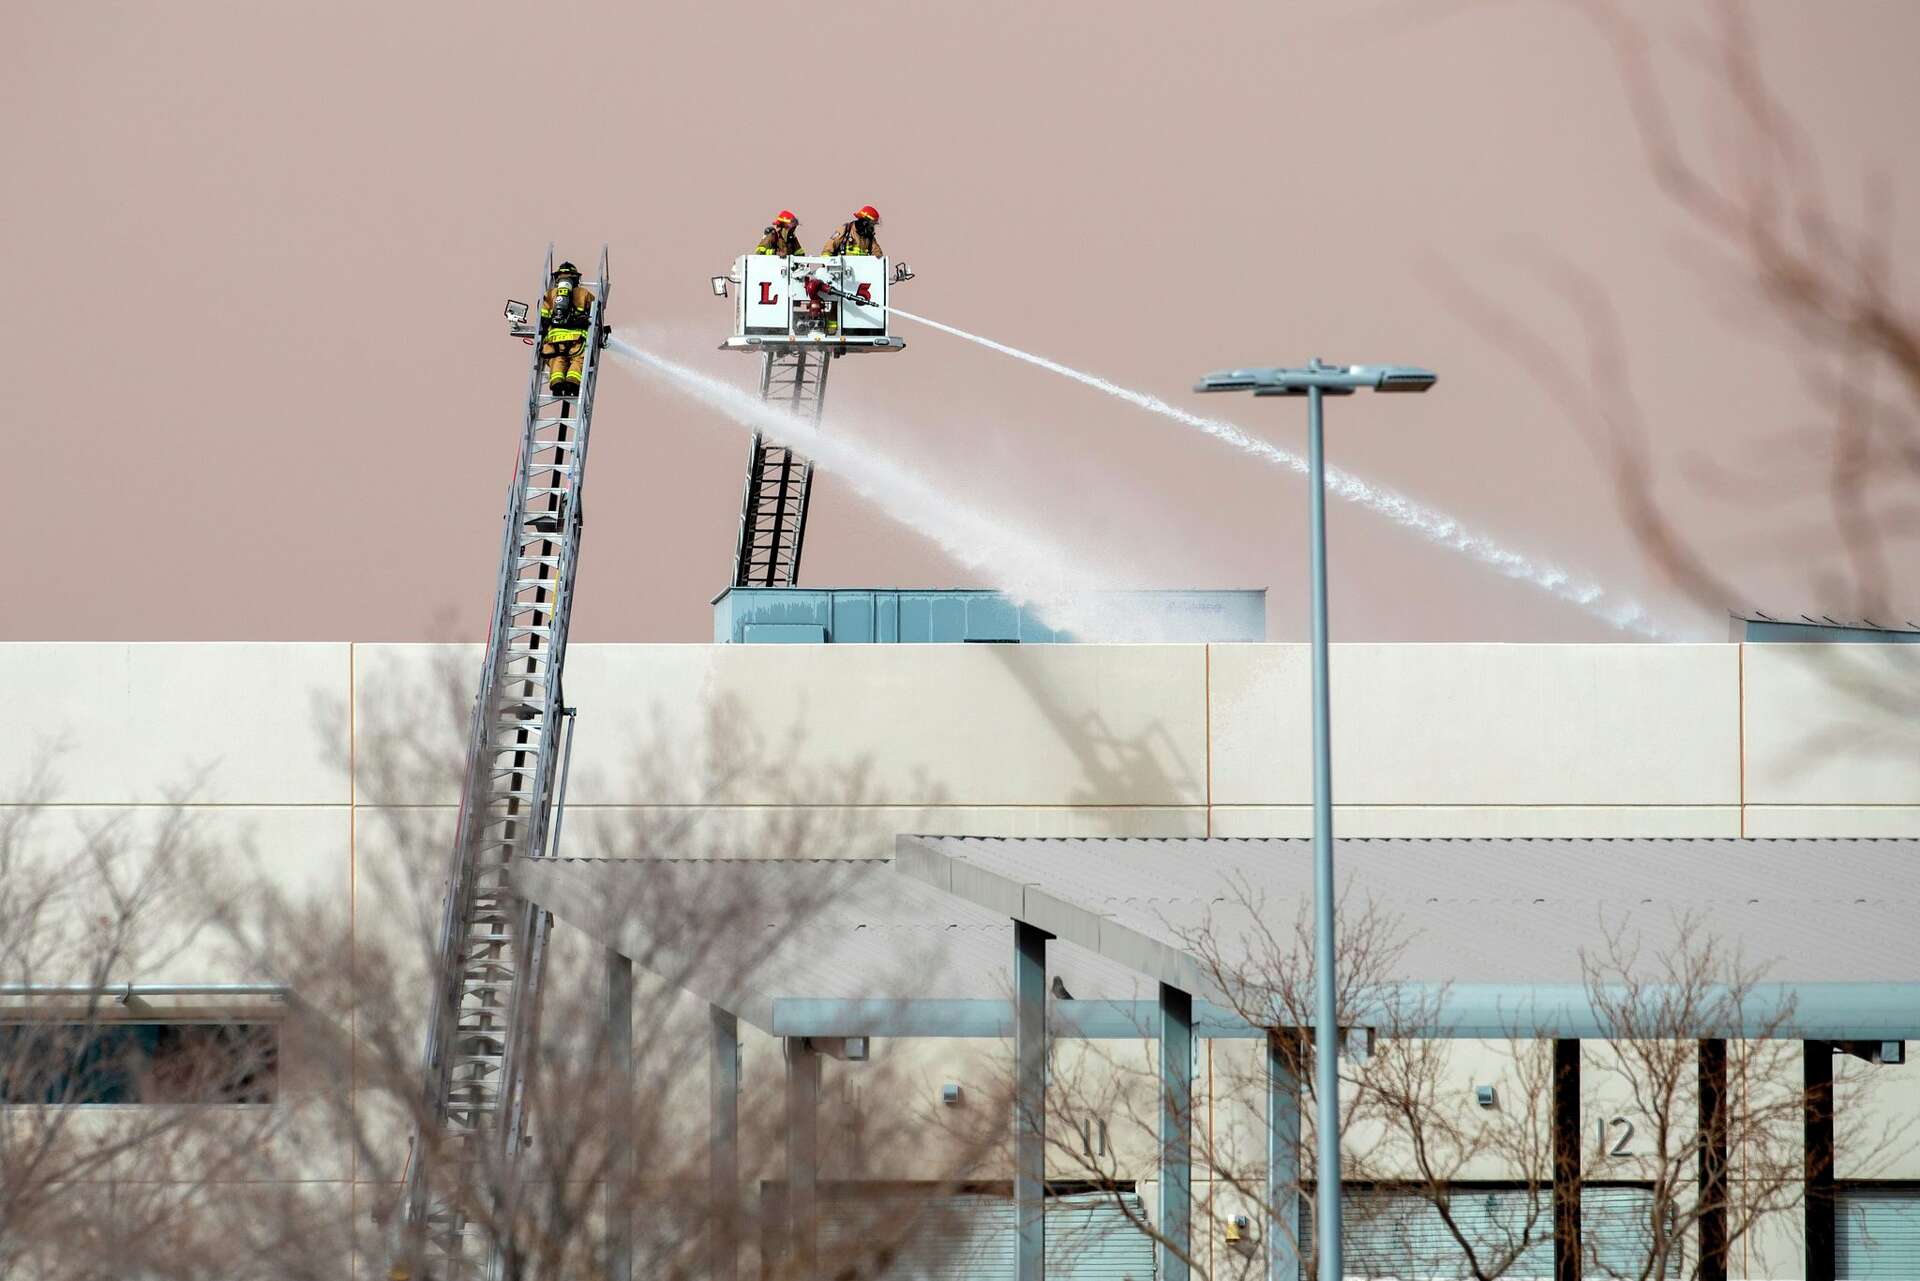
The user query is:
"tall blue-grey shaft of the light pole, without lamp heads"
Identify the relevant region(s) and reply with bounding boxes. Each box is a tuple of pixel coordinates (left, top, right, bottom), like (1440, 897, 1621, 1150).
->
(1308, 372, 1346, 1281)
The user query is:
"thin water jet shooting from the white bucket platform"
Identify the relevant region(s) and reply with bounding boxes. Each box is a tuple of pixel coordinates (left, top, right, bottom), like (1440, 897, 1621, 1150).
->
(887, 303, 1665, 640)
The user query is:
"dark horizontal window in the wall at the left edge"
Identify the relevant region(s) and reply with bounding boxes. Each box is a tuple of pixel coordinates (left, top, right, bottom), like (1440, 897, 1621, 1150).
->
(0, 1020, 280, 1106)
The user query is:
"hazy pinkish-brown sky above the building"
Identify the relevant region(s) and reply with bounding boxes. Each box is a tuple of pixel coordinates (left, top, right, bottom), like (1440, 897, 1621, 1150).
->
(0, 0, 1920, 640)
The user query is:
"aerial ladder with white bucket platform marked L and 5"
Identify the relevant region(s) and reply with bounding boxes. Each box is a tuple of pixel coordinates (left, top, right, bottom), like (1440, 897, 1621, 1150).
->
(712, 254, 914, 588)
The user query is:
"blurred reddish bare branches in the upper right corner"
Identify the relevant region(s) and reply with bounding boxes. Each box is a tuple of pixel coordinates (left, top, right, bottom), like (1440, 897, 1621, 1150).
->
(1444, 0, 1920, 729)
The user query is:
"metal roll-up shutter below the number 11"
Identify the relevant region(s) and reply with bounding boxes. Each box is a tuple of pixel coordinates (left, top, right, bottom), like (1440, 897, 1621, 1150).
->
(820, 1193, 1154, 1281)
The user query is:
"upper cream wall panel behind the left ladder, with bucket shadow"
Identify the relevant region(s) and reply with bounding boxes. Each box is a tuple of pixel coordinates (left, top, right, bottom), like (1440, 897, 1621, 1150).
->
(357, 645, 1206, 807)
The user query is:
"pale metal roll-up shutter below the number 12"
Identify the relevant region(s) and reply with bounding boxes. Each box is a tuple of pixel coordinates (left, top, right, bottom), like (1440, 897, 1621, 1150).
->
(1300, 1187, 1678, 1281)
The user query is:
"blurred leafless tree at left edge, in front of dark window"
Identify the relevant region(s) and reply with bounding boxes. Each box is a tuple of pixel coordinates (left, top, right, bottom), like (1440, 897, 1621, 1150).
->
(0, 757, 275, 1277)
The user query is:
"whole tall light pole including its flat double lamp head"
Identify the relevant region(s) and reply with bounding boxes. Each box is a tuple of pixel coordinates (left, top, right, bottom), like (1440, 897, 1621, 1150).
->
(1194, 357, 1438, 1281)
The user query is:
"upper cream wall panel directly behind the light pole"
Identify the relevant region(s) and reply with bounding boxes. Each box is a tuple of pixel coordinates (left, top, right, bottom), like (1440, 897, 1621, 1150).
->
(1212, 645, 1740, 805)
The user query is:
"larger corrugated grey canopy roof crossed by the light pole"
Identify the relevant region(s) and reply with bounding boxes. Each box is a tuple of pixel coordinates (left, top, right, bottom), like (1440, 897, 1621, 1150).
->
(895, 835, 1920, 1039)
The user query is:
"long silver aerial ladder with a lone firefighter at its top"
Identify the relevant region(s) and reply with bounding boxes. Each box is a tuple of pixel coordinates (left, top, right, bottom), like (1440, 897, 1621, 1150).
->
(392, 246, 609, 1281)
